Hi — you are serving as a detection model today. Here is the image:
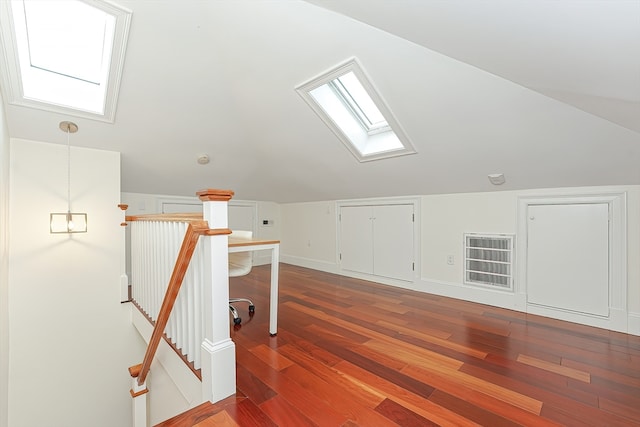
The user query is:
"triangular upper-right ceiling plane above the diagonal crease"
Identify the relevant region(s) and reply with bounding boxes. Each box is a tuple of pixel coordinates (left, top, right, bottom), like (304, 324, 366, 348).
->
(308, 0, 640, 132)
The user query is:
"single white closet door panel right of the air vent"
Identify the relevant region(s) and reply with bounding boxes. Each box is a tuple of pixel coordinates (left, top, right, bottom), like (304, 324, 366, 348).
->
(527, 203, 609, 316)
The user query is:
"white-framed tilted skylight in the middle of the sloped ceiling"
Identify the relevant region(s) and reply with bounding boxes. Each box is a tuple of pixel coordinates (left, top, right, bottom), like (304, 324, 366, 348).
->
(297, 59, 416, 162)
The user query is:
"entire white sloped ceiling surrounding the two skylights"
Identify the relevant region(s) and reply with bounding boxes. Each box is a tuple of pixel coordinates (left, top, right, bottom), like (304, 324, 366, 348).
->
(1, 0, 640, 202)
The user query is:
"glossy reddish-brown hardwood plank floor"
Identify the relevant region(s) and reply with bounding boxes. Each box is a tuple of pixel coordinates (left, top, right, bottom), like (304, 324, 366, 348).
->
(159, 264, 640, 427)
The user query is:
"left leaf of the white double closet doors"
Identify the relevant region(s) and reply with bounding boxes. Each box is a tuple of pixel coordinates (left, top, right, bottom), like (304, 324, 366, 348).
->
(340, 206, 373, 274)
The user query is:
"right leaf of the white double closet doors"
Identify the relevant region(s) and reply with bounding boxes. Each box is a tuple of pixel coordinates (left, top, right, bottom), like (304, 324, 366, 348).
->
(373, 205, 414, 281)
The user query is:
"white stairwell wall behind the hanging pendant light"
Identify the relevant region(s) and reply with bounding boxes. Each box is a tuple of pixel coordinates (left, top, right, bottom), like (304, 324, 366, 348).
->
(8, 140, 144, 427)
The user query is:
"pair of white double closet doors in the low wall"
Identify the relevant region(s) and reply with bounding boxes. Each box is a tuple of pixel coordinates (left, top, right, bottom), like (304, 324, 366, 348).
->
(340, 204, 414, 281)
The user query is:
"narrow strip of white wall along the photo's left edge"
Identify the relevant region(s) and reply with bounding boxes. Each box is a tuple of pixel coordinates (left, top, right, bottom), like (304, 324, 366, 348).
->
(0, 89, 9, 427)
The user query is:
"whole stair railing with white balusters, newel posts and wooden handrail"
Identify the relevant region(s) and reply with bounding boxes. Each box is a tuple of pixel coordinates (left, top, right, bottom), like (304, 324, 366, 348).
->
(127, 189, 236, 427)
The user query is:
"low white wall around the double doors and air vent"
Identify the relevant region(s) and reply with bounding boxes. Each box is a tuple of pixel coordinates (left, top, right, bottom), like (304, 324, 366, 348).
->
(281, 186, 640, 335)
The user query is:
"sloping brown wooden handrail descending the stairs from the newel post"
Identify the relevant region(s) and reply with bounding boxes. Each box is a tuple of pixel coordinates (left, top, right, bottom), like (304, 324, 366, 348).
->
(132, 221, 231, 385)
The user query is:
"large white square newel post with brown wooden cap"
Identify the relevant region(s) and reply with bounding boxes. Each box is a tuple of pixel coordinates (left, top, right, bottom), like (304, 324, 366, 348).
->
(196, 189, 236, 402)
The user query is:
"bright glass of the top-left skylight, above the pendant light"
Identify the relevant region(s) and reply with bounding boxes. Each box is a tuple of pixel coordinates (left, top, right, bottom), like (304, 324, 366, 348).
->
(13, 0, 115, 114)
